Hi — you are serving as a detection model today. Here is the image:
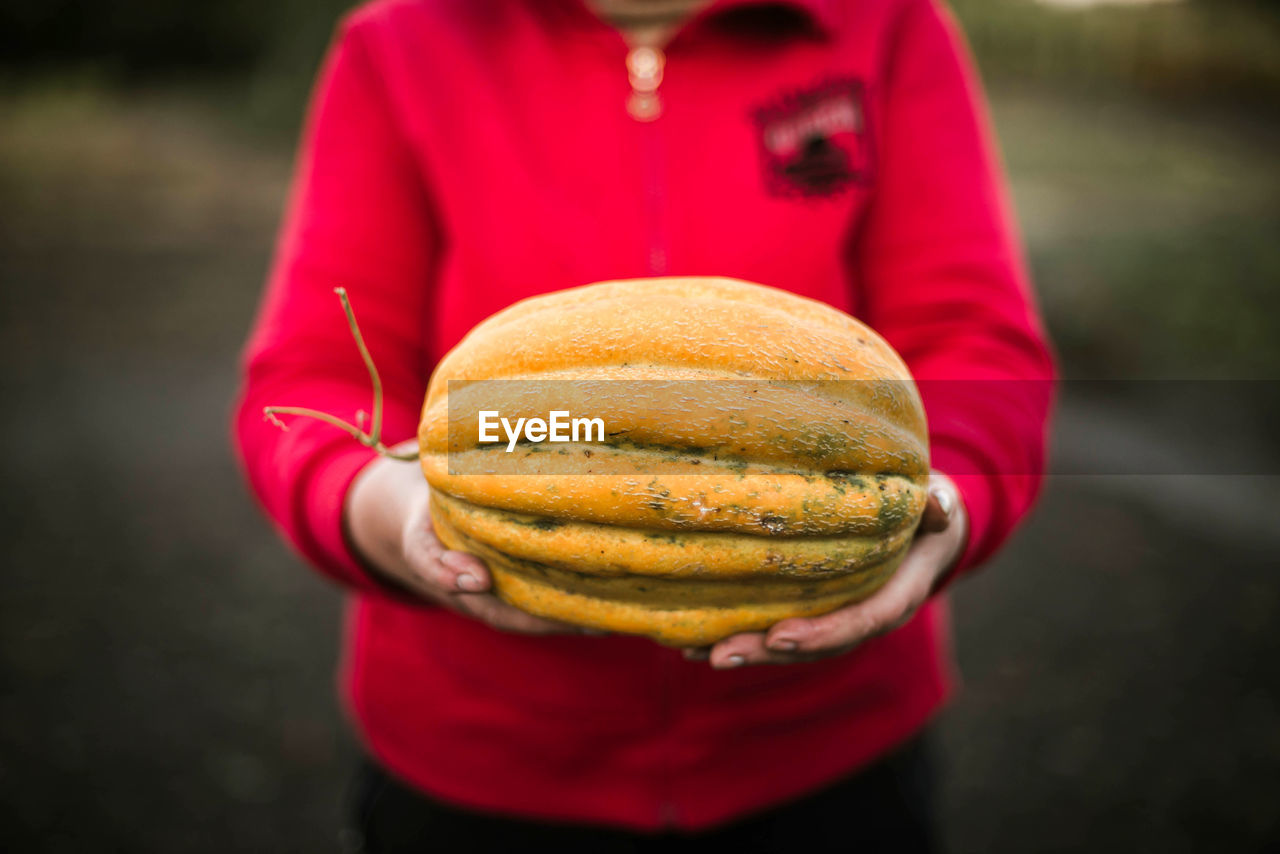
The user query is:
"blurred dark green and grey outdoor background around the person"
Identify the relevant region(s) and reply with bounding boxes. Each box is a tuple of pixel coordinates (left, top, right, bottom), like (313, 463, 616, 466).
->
(0, 0, 1280, 851)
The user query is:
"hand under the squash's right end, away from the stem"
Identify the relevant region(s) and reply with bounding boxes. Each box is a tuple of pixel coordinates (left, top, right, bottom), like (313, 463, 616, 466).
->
(685, 471, 969, 670)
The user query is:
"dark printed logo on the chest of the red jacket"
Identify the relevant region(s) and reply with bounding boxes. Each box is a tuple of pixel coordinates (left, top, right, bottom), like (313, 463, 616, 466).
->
(753, 78, 873, 197)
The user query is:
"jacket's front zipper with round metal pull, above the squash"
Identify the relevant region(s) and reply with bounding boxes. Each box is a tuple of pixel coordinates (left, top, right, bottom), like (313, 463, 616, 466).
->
(627, 45, 668, 275)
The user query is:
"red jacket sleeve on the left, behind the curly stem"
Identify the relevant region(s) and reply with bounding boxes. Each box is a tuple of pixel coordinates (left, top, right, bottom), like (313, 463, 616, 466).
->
(226, 20, 438, 589)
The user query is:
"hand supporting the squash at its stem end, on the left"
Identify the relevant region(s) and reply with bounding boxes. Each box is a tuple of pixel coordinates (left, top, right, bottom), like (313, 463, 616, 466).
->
(343, 443, 586, 635)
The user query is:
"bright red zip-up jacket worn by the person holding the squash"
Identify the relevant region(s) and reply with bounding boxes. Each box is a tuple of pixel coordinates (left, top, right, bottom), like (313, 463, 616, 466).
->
(234, 0, 1052, 828)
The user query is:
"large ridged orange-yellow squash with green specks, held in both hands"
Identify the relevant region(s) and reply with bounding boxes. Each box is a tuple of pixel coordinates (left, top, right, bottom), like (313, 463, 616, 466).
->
(419, 278, 928, 647)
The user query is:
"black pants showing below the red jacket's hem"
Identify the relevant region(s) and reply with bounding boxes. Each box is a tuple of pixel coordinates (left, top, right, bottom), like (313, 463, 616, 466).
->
(351, 737, 940, 854)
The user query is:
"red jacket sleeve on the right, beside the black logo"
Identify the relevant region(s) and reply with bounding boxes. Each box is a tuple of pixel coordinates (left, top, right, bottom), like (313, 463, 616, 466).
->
(854, 0, 1053, 581)
